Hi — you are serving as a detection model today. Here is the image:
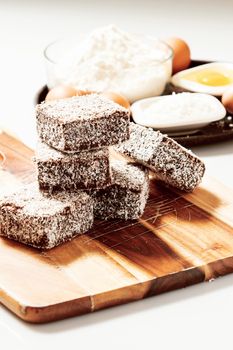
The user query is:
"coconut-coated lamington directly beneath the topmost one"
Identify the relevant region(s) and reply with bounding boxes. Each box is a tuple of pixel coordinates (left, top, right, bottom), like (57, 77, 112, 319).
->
(34, 141, 111, 192)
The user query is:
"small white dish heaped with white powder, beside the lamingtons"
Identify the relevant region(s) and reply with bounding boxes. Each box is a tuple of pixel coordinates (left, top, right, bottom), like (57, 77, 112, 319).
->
(132, 92, 226, 128)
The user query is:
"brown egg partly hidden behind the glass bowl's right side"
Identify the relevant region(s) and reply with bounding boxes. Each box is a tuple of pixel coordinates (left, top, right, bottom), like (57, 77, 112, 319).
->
(164, 38, 191, 74)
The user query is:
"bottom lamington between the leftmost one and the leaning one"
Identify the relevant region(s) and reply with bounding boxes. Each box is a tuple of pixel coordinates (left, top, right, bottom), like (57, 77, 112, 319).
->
(90, 161, 149, 220)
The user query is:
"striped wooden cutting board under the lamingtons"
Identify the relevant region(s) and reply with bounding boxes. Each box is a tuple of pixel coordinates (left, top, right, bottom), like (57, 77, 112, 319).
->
(0, 133, 233, 322)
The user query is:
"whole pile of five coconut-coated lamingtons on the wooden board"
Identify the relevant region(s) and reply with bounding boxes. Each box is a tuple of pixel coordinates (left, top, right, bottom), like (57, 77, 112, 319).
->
(0, 94, 205, 249)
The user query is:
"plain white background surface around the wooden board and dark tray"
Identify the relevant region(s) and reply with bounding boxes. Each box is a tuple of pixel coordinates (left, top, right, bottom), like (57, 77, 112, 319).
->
(0, 0, 233, 350)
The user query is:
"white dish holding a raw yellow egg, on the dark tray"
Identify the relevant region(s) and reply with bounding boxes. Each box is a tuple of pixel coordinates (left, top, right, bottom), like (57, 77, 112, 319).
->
(171, 62, 233, 96)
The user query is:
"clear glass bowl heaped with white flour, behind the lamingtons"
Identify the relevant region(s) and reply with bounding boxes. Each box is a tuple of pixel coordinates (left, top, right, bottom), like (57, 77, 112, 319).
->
(44, 25, 173, 103)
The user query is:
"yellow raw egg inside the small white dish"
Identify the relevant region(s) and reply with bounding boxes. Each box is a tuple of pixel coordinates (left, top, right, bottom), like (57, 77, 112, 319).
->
(186, 69, 233, 86)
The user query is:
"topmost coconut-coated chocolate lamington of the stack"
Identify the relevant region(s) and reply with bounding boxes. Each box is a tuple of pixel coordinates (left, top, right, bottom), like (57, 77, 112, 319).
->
(36, 94, 129, 152)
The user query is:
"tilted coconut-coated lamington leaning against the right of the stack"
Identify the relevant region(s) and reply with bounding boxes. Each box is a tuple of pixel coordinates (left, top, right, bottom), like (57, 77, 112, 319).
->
(114, 123, 205, 192)
